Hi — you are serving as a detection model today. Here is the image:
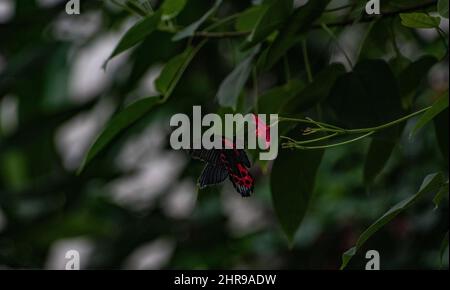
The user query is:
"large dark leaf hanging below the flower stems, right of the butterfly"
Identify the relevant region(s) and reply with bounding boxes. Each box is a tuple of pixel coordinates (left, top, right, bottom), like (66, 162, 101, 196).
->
(270, 127, 324, 243)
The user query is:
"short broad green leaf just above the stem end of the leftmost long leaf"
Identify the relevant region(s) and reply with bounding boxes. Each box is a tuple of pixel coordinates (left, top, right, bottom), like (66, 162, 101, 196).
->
(155, 41, 205, 100)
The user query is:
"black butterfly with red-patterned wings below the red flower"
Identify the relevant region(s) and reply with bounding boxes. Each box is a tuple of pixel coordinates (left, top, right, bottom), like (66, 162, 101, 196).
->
(189, 137, 255, 197)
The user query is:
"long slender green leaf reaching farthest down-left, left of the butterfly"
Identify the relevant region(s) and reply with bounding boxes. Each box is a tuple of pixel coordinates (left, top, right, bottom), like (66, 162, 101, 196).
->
(78, 97, 160, 173)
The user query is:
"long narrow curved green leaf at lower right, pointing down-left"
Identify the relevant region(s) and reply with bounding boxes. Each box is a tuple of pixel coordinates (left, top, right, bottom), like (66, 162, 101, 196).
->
(341, 173, 445, 270)
